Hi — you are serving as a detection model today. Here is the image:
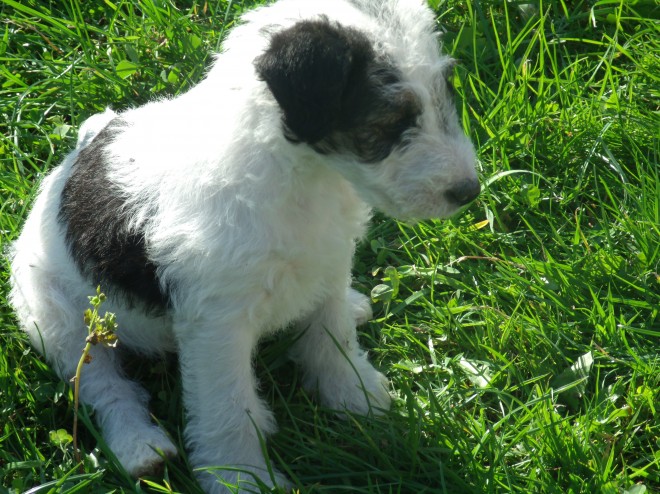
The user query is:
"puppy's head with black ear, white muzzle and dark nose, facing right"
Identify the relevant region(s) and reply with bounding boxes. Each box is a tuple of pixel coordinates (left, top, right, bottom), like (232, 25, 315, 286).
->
(255, 18, 480, 219)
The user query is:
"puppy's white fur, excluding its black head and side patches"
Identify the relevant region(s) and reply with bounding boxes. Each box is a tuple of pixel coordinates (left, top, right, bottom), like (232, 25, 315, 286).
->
(11, 0, 476, 493)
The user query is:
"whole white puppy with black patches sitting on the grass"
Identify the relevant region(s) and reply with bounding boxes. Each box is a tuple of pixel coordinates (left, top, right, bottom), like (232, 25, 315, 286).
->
(10, 0, 480, 492)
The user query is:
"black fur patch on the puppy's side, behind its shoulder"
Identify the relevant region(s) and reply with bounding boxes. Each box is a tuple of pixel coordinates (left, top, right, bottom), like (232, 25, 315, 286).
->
(58, 117, 170, 312)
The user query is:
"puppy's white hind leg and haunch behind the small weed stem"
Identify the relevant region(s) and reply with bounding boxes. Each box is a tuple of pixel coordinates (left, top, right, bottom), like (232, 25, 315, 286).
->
(11, 264, 176, 477)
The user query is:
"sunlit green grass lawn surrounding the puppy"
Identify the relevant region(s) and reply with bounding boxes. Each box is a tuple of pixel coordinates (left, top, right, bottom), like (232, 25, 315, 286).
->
(0, 0, 660, 494)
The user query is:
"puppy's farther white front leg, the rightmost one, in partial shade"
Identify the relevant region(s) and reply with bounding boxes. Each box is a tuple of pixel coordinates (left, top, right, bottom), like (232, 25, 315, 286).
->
(291, 288, 391, 415)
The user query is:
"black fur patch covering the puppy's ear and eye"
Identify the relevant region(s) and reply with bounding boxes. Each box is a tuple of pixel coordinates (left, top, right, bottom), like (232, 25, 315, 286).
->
(255, 19, 421, 162)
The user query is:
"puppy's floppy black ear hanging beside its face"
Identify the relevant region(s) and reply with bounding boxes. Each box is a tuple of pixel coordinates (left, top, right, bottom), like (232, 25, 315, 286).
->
(254, 20, 374, 144)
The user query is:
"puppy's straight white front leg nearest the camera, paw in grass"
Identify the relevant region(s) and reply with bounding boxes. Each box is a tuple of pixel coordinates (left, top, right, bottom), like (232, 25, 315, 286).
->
(176, 317, 287, 494)
